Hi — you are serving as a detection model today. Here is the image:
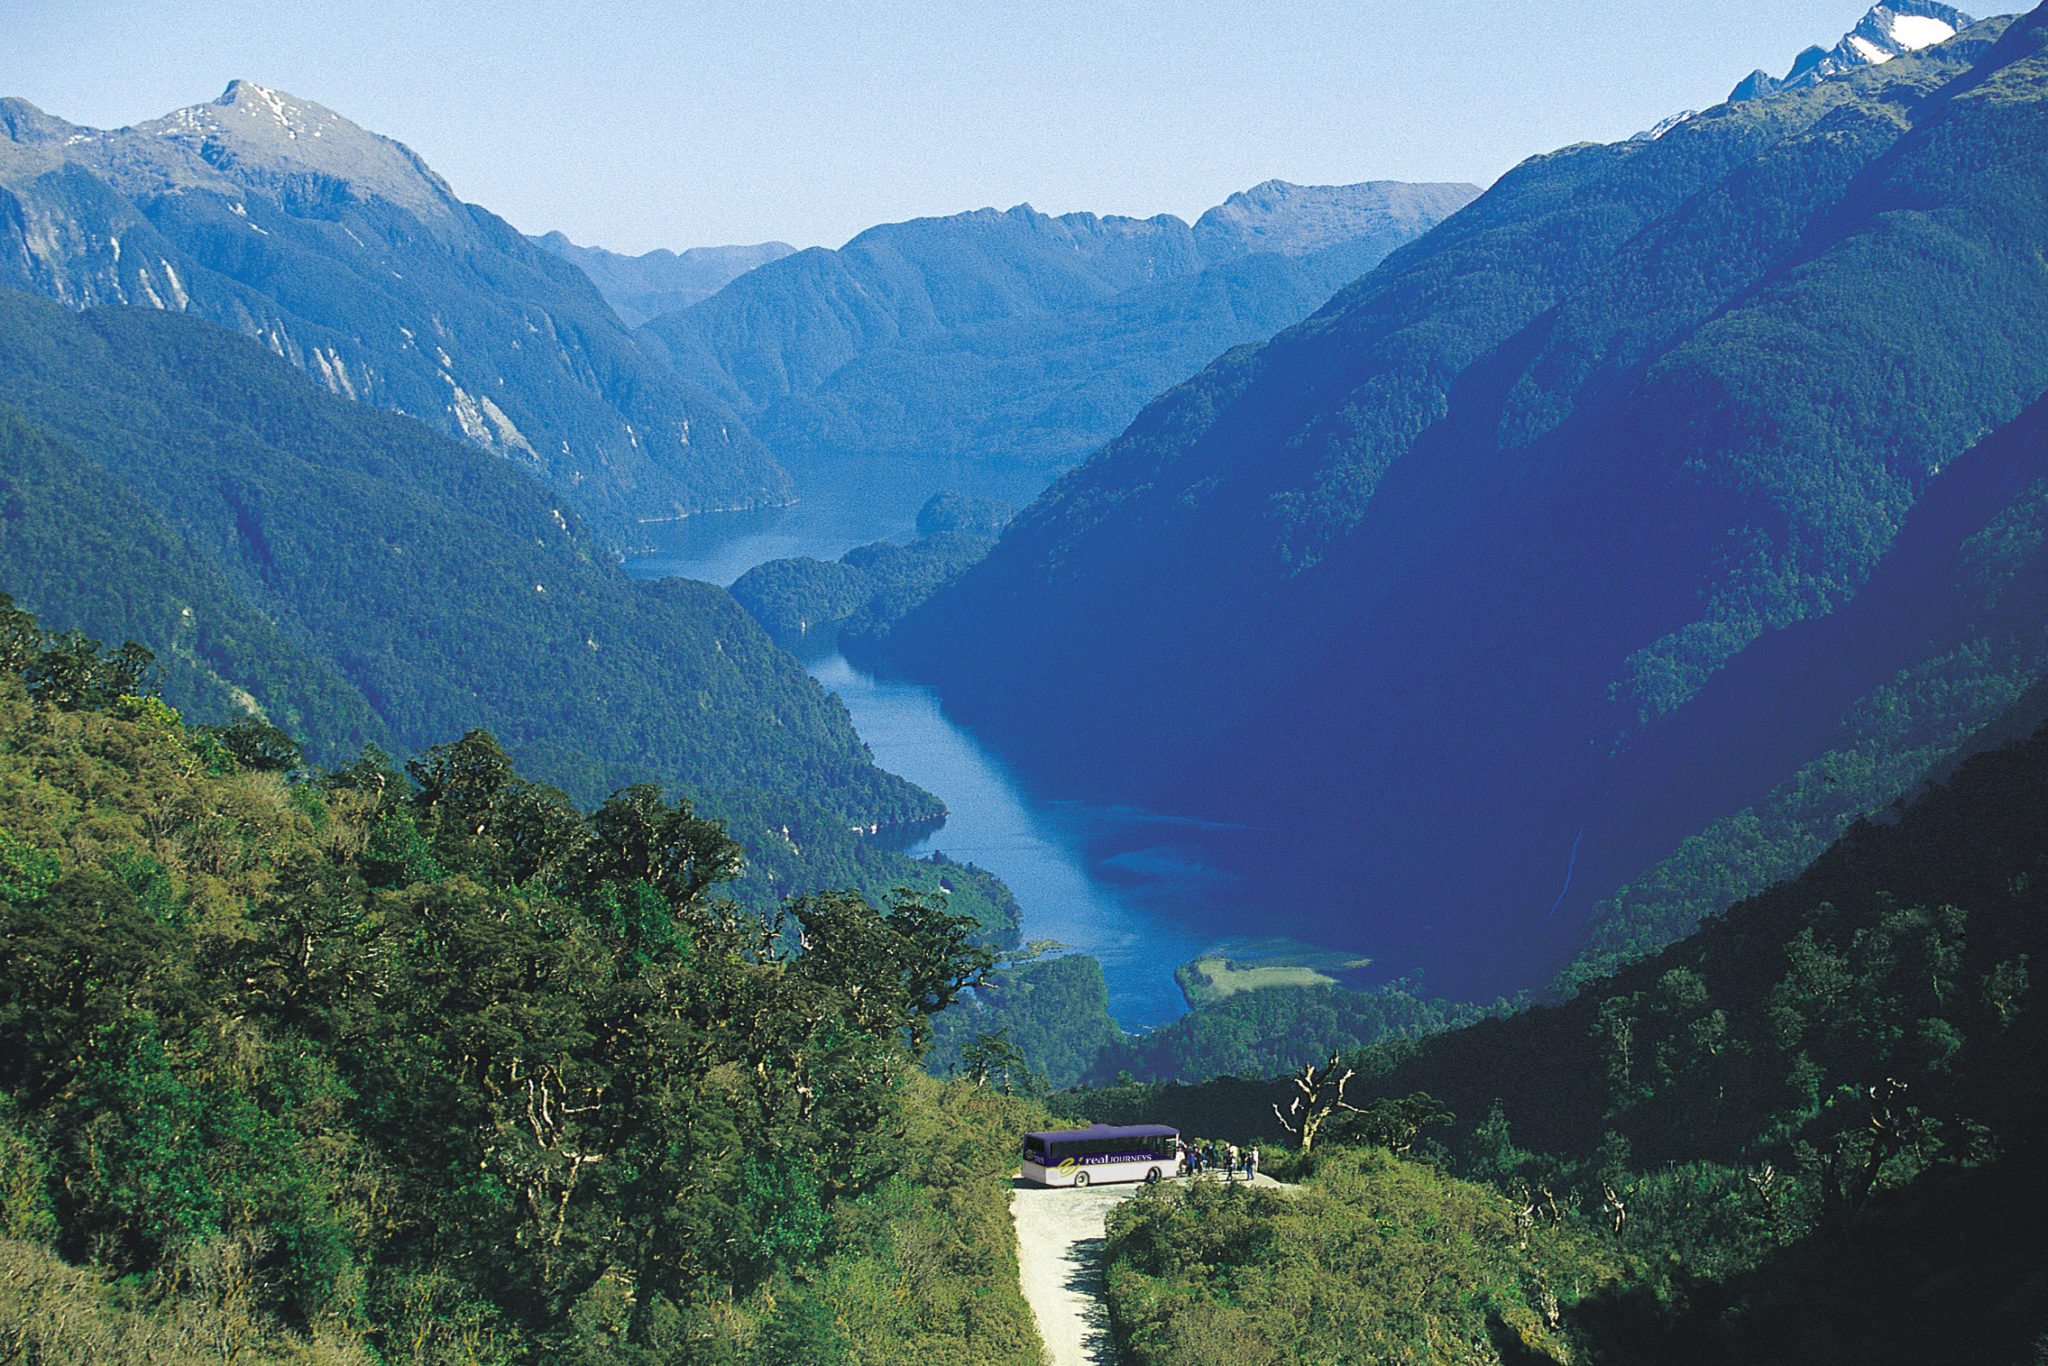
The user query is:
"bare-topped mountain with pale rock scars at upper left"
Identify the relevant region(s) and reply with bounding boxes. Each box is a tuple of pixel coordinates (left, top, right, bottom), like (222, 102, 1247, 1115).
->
(0, 82, 788, 545)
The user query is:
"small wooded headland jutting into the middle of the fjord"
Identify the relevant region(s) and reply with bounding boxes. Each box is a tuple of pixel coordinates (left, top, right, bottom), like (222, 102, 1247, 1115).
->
(731, 492, 1010, 643)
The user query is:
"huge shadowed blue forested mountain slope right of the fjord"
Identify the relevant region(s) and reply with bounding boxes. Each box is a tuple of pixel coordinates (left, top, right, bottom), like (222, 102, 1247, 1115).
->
(889, 14, 2048, 995)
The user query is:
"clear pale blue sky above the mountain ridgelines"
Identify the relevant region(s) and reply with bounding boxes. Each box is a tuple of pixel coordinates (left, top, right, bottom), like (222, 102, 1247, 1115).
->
(0, 0, 1982, 252)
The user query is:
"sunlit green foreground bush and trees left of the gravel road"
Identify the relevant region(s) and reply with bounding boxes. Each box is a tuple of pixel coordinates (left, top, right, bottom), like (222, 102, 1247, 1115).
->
(0, 604, 1044, 1366)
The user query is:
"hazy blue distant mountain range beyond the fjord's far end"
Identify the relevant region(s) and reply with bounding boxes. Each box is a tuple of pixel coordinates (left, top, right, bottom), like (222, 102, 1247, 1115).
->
(643, 180, 1479, 494)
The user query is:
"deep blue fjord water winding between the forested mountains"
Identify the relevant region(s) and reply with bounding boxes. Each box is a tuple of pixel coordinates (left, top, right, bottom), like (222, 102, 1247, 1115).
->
(627, 500, 1257, 1030)
